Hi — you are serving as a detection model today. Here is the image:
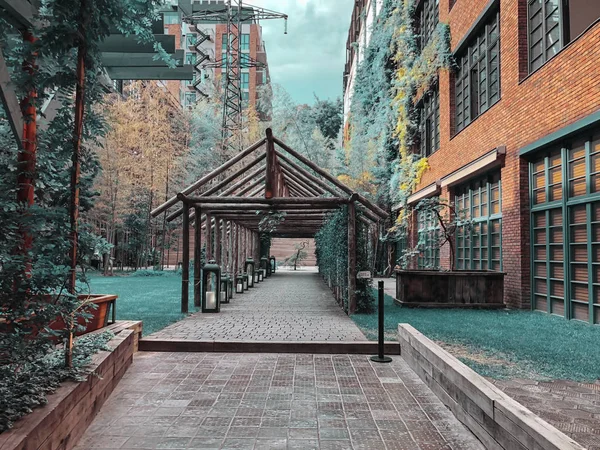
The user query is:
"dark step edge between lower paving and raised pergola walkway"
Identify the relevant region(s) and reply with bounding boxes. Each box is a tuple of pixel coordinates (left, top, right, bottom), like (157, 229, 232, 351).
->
(139, 338, 400, 355)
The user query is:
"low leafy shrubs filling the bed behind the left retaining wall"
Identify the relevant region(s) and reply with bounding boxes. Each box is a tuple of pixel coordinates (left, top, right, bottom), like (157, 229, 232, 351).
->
(0, 331, 114, 433)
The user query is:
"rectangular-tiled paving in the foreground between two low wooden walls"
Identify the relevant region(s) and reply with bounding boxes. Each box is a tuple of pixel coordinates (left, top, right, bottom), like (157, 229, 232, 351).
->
(76, 352, 484, 450)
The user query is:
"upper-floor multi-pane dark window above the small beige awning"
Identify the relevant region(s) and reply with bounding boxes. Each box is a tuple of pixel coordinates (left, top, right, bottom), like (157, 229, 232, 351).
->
(455, 12, 500, 132)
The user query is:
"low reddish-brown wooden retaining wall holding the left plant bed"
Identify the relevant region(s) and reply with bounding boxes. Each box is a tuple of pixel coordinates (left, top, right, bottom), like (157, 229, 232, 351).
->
(0, 330, 134, 450)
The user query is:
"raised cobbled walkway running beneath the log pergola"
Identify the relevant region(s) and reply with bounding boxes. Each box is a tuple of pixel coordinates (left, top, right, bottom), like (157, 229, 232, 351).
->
(149, 271, 367, 342)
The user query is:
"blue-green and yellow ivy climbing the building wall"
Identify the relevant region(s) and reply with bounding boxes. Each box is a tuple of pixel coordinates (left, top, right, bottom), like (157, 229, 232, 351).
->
(345, 0, 452, 223)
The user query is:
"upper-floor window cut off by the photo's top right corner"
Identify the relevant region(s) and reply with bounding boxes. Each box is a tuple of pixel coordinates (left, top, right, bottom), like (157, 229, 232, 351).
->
(527, 0, 600, 72)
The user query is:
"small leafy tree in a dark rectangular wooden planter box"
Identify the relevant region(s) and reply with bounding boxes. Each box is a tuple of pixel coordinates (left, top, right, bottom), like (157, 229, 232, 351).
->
(395, 197, 504, 308)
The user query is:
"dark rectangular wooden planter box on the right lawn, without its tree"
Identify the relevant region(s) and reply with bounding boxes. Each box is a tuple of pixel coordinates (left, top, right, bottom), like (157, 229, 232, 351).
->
(396, 270, 504, 308)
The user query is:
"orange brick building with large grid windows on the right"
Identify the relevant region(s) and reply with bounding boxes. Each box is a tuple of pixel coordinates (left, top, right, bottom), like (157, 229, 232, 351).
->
(344, 0, 600, 323)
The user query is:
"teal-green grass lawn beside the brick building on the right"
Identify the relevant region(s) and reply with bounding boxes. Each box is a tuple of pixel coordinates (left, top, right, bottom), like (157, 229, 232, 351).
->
(352, 295, 600, 381)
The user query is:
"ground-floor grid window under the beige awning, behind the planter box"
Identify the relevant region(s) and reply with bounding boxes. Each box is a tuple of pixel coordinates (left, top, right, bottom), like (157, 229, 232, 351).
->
(454, 172, 502, 270)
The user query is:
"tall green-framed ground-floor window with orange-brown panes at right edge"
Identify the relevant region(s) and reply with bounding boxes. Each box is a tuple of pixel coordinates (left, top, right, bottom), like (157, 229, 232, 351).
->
(530, 134, 600, 323)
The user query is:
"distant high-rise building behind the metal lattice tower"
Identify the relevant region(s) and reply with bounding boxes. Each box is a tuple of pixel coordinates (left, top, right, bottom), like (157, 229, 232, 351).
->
(163, 0, 270, 108)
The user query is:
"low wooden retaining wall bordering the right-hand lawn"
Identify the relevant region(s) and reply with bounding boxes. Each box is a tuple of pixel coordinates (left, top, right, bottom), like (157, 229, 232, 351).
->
(398, 324, 585, 450)
